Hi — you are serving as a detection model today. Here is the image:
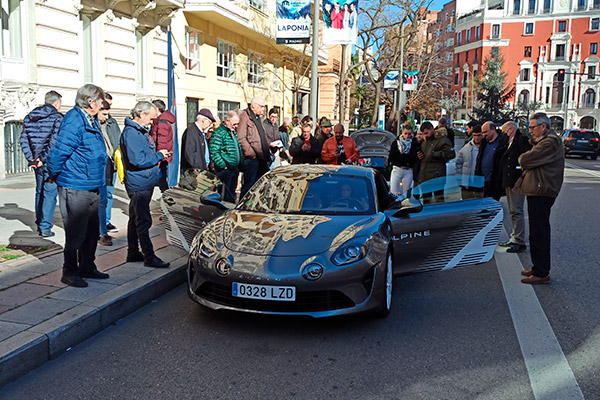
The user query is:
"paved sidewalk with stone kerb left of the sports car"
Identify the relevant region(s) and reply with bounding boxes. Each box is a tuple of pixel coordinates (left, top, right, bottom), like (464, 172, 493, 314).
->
(0, 174, 187, 387)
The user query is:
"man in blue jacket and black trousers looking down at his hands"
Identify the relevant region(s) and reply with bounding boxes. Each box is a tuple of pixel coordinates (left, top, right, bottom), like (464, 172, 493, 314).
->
(121, 101, 170, 268)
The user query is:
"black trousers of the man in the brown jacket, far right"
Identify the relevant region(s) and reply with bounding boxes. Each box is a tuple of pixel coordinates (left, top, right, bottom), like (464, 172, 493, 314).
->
(527, 196, 555, 278)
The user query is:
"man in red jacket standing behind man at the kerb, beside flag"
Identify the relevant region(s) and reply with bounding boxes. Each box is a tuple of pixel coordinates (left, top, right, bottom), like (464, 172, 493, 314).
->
(150, 100, 175, 192)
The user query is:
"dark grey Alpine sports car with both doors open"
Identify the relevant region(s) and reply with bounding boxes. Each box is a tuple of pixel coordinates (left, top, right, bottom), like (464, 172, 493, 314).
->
(161, 165, 502, 317)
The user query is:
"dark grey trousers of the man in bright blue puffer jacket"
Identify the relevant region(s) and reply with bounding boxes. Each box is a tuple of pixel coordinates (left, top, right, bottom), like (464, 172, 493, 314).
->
(58, 187, 100, 276)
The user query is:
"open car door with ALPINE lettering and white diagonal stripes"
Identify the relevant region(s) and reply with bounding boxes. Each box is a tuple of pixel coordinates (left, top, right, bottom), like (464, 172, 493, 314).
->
(385, 175, 503, 274)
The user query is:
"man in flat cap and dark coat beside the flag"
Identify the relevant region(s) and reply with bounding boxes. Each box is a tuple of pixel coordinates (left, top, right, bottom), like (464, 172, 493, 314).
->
(181, 108, 215, 174)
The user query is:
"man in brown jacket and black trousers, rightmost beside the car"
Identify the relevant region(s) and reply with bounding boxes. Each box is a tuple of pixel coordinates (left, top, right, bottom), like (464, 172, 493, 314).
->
(514, 112, 565, 284)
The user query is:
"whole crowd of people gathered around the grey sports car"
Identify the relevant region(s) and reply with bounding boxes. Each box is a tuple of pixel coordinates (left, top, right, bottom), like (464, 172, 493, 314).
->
(20, 84, 564, 287)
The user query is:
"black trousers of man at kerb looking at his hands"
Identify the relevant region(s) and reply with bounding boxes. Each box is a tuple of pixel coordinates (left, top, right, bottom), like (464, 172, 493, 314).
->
(127, 188, 154, 261)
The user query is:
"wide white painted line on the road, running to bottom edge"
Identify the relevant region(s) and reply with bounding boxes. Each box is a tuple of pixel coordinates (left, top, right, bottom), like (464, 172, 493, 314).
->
(494, 247, 584, 400)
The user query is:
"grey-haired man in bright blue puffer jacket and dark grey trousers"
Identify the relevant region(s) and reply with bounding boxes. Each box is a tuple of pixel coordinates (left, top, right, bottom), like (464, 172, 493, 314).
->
(47, 84, 108, 287)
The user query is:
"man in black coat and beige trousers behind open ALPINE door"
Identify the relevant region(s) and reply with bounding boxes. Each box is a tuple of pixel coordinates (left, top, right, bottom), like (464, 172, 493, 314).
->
(496, 121, 531, 253)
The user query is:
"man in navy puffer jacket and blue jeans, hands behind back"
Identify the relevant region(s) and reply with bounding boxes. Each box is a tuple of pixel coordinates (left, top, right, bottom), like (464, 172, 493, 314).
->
(19, 90, 63, 237)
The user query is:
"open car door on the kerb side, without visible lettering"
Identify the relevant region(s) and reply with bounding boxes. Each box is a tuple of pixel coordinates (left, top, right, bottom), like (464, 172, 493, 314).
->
(160, 187, 234, 251)
